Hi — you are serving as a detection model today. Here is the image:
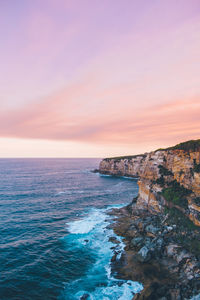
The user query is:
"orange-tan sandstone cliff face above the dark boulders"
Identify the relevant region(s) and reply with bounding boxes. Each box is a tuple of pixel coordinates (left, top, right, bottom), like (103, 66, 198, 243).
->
(99, 140, 200, 226)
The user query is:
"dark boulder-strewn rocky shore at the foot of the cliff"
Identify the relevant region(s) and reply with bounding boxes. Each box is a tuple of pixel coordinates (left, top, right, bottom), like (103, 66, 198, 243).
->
(108, 200, 200, 300)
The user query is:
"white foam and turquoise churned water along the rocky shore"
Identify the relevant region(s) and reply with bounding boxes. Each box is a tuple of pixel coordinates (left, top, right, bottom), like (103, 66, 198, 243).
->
(62, 209, 143, 300)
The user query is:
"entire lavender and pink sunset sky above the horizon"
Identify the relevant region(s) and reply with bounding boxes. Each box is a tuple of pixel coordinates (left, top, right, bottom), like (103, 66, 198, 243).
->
(0, 0, 200, 157)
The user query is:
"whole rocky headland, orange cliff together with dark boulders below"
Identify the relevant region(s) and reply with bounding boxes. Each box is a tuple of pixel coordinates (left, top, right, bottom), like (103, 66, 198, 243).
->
(99, 140, 200, 300)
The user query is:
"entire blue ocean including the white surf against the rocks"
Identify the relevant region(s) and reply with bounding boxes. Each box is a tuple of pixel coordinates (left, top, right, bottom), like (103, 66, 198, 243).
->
(0, 159, 142, 300)
